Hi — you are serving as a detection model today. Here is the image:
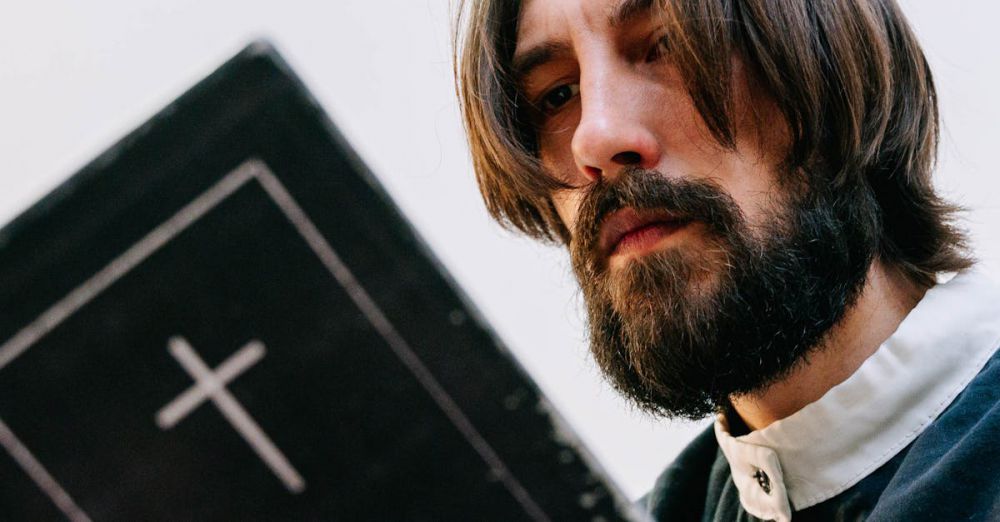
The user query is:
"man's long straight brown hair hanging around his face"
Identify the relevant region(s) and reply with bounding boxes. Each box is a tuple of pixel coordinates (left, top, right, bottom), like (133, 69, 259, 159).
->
(455, 0, 972, 285)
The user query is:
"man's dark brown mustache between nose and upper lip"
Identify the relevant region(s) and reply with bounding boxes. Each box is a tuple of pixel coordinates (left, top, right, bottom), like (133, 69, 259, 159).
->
(571, 166, 743, 260)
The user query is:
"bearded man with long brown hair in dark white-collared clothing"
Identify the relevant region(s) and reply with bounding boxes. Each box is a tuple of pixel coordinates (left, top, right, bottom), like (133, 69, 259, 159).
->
(456, 0, 1000, 521)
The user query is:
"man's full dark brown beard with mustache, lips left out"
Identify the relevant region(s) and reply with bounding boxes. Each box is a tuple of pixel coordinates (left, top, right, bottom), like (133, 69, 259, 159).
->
(570, 169, 877, 419)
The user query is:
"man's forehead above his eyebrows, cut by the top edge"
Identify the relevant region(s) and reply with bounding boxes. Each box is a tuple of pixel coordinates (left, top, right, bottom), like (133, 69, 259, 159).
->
(517, 0, 654, 48)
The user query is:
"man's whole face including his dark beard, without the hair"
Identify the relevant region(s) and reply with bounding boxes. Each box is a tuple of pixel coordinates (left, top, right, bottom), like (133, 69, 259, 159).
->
(513, 0, 871, 417)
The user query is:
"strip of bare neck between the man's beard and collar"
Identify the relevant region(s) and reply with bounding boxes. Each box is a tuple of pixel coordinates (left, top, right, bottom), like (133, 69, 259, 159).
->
(730, 261, 926, 430)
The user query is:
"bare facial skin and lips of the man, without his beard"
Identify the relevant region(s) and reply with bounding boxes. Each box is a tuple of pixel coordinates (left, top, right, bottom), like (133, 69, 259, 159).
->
(514, 0, 783, 260)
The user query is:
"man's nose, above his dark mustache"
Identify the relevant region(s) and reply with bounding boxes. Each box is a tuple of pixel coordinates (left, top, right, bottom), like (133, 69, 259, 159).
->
(571, 70, 660, 182)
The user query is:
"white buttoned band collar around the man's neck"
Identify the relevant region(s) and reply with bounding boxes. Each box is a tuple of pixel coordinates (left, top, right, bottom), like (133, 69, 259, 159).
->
(715, 270, 1000, 522)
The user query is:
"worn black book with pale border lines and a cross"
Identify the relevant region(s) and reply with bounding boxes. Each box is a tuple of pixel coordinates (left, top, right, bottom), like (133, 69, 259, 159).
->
(0, 43, 630, 522)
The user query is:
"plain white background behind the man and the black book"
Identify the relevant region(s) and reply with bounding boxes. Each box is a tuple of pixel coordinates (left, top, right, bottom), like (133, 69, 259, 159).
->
(0, 0, 1000, 497)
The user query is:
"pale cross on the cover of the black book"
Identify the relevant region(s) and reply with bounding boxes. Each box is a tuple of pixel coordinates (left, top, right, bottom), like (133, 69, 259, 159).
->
(156, 337, 306, 493)
